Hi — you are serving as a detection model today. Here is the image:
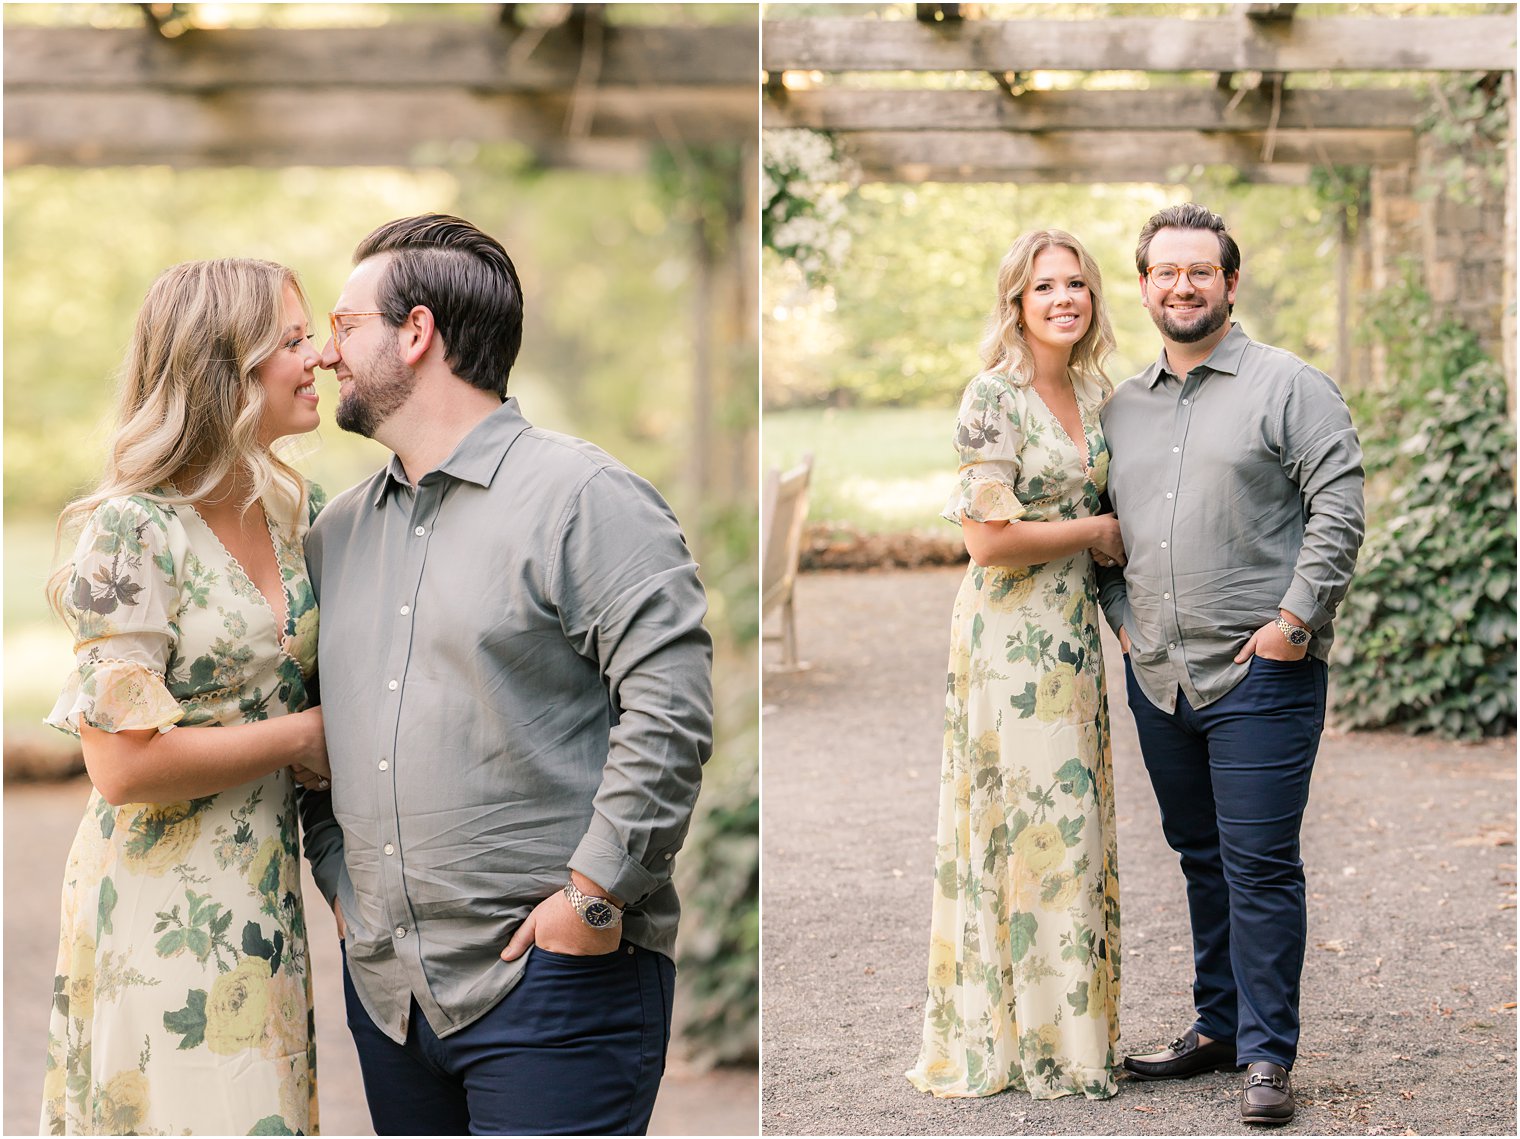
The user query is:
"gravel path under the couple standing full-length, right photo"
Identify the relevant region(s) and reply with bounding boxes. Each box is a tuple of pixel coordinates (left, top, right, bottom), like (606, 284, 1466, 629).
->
(762, 570, 1515, 1136)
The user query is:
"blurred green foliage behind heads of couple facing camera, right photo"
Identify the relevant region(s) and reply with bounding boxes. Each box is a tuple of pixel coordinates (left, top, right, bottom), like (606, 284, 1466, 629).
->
(763, 177, 1338, 415)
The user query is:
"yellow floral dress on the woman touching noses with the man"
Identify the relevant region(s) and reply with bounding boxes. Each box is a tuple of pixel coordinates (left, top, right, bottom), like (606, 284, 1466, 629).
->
(41, 488, 321, 1134)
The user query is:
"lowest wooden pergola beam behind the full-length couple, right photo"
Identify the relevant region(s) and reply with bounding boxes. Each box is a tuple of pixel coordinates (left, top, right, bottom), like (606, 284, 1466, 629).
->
(841, 131, 1415, 181)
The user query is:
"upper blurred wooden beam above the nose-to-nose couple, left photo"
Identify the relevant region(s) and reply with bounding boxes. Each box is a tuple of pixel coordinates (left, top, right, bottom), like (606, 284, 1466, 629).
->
(5, 23, 758, 97)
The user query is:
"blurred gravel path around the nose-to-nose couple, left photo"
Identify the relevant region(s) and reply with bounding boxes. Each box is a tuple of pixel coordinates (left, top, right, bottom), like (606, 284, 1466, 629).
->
(3, 779, 760, 1134)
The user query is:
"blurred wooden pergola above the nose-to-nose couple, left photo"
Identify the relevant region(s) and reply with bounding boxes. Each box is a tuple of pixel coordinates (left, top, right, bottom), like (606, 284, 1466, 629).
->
(5, 3, 758, 502)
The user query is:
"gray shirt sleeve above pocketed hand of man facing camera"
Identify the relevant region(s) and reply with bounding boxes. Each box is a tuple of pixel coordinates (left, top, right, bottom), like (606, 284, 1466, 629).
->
(1281, 368, 1366, 630)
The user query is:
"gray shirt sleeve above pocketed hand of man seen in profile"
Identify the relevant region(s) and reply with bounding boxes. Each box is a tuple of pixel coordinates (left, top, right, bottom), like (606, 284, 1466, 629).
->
(550, 467, 713, 906)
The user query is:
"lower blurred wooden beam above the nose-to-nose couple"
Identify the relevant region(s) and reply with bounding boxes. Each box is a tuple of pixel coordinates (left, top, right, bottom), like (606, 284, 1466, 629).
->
(5, 88, 755, 169)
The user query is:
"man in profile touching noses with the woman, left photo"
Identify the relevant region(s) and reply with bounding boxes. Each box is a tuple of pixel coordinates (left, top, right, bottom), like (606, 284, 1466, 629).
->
(302, 214, 711, 1134)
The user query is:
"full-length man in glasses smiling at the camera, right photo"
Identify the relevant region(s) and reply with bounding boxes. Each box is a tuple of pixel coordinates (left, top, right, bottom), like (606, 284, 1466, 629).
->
(1102, 204, 1362, 1124)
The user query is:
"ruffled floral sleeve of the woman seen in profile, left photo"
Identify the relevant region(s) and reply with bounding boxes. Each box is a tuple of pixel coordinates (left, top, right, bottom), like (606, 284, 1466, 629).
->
(47, 496, 184, 734)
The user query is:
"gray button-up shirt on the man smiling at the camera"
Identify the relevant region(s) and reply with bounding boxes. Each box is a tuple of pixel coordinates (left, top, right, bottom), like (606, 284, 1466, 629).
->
(1099, 324, 1363, 712)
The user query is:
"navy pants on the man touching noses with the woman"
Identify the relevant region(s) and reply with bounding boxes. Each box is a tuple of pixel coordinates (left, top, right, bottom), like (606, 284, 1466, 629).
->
(344, 941, 675, 1134)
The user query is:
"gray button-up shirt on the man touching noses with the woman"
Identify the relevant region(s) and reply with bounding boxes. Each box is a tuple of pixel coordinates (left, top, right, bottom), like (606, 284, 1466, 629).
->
(302, 400, 713, 1042)
